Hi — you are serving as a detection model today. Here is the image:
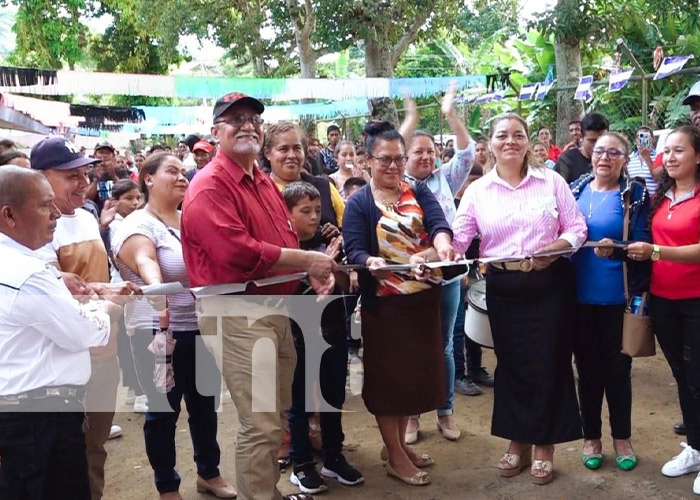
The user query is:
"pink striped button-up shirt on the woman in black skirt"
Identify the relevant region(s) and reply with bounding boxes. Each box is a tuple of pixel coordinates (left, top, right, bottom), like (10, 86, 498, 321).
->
(452, 167, 588, 257)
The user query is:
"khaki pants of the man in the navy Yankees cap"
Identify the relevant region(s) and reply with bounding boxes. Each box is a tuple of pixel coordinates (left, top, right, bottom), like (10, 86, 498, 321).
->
(85, 357, 119, 500)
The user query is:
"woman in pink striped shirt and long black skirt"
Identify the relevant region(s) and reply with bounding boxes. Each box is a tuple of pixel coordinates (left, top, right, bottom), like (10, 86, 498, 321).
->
(452, 114, 587, 484)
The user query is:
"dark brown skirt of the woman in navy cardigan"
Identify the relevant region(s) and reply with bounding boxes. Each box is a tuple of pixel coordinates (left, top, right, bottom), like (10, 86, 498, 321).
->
(361, 286, 447, 416)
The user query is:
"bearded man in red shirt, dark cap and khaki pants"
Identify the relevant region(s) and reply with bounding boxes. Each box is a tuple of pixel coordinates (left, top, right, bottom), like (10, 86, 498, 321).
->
(181, 93, 335, 500)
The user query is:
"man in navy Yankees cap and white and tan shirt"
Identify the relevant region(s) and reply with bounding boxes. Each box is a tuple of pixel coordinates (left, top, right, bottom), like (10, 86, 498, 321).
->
(30, 137, 140, 500)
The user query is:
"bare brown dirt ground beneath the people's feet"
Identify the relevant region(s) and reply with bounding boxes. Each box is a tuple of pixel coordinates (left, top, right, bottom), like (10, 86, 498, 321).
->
(105, 350, 695, 500)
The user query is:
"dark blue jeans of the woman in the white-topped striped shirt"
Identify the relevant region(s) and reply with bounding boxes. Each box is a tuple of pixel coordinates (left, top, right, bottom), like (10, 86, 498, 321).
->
(131, 330, 221, 493)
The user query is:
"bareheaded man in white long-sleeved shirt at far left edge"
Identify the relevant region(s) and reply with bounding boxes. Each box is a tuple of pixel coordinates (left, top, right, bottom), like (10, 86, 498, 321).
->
(0, 166, 121, 500)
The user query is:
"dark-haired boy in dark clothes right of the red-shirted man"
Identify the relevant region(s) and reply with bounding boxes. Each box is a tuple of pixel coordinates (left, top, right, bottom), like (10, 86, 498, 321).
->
(282, 182, 364, 494)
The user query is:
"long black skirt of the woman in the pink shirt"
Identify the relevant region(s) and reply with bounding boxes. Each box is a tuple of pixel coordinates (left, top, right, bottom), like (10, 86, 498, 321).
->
(486, 259, 582, 445)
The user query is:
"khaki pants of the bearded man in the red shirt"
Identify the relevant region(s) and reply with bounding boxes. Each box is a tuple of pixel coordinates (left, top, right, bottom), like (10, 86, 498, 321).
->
(200, 297, 296, 500)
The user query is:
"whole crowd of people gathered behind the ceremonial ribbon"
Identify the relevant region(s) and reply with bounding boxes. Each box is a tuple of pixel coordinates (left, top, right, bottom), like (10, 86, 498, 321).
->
(0, 78, 700, 500)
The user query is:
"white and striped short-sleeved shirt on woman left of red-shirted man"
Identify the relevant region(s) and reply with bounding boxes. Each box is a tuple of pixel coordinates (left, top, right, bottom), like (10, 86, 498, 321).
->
(112, 209, 198, 334)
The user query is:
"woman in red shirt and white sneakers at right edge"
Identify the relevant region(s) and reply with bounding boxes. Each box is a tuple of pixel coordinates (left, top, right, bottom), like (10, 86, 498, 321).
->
(627, 126, 700, 494)
